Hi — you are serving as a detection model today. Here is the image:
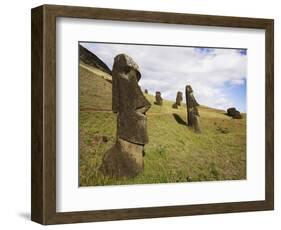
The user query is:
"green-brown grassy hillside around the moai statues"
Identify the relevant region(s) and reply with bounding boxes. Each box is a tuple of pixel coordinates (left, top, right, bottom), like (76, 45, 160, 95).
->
(80, 65, 246, 186)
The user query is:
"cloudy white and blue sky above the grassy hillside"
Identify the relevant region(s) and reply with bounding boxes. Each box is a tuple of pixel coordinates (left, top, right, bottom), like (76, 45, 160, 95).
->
(80, 42, 247, 112)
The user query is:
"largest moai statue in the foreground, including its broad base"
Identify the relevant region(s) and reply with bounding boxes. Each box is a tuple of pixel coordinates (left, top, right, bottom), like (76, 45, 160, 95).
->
(100, 54, 151, 178)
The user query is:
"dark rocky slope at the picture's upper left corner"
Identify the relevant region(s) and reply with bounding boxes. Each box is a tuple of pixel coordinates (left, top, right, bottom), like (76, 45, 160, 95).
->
(79, 45, 111, 75)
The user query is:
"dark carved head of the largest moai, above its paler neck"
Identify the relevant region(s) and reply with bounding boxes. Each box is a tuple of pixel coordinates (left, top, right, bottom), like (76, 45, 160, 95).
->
(112, 54, 151, 144)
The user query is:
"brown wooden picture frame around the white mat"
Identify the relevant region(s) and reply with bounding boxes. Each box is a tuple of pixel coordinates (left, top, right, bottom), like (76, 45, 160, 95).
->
(31, 5, 274, 224)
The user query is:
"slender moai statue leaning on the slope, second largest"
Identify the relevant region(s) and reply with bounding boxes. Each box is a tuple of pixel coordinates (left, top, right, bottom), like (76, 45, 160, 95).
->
(185, 85, 201, 133)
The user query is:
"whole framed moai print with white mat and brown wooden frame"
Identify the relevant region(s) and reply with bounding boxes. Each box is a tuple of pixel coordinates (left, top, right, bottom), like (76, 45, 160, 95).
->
(31, 5, 274, 224)
